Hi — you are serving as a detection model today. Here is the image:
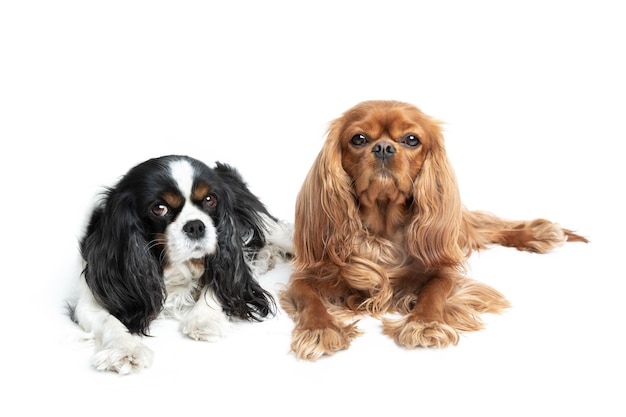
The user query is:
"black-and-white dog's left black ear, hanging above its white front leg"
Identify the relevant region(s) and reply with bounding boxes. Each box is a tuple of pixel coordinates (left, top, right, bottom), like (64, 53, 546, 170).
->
(80, 190, 165, 335)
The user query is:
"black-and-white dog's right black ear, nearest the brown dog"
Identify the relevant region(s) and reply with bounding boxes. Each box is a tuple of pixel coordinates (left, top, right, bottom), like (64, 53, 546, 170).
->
(204, 163, 275, 321)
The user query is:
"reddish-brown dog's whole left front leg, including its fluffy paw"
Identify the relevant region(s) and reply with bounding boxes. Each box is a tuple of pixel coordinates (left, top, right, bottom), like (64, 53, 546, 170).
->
(280, 273, 359, 360)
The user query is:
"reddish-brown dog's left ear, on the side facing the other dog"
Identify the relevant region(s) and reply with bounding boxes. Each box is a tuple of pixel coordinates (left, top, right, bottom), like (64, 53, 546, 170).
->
(294, 118, 361, 268)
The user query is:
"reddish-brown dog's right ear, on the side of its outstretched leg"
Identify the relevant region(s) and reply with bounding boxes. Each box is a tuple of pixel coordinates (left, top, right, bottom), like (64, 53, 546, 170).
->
(407, 126, 465, 268)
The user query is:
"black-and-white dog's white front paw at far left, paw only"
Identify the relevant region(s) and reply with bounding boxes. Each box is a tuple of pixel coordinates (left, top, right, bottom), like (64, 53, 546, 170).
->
(92, 335, 154, 375)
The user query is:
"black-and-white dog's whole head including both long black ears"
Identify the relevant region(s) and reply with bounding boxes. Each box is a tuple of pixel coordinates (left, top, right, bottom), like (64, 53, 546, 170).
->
(81, 155, 272, 333)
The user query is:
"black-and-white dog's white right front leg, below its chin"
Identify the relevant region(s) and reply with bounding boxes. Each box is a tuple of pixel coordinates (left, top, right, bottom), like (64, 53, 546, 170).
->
(181, 286, 230, 342)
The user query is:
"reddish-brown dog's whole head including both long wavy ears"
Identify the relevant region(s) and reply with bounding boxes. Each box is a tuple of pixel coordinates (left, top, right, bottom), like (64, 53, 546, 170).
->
(295, 101, 463, 266)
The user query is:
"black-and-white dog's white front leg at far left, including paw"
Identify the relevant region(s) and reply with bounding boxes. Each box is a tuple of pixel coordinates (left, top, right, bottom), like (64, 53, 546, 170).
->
(74, 277, 153, 374)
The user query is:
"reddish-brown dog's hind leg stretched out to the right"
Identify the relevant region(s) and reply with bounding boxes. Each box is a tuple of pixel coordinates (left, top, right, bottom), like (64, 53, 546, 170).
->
(463, 211, 588, 253)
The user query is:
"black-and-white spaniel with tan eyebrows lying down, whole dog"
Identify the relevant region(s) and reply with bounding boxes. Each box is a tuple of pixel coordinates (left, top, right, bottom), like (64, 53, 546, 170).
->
(68, 155, 292, 374)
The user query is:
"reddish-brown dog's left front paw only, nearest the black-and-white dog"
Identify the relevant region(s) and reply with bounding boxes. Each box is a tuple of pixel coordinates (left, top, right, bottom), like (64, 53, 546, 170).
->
(291, 323, 360, 361)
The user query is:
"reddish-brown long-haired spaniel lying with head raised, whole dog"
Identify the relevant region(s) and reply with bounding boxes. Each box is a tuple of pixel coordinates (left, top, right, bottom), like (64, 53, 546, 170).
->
(279, 101, 587, 360)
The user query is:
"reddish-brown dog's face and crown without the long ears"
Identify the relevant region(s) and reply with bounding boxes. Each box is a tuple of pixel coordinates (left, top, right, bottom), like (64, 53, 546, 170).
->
(331, 101, 441, 213)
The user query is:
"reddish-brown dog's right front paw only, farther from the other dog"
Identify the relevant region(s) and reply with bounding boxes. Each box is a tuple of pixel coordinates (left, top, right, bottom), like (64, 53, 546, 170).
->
(383, 317, 459, 349)
